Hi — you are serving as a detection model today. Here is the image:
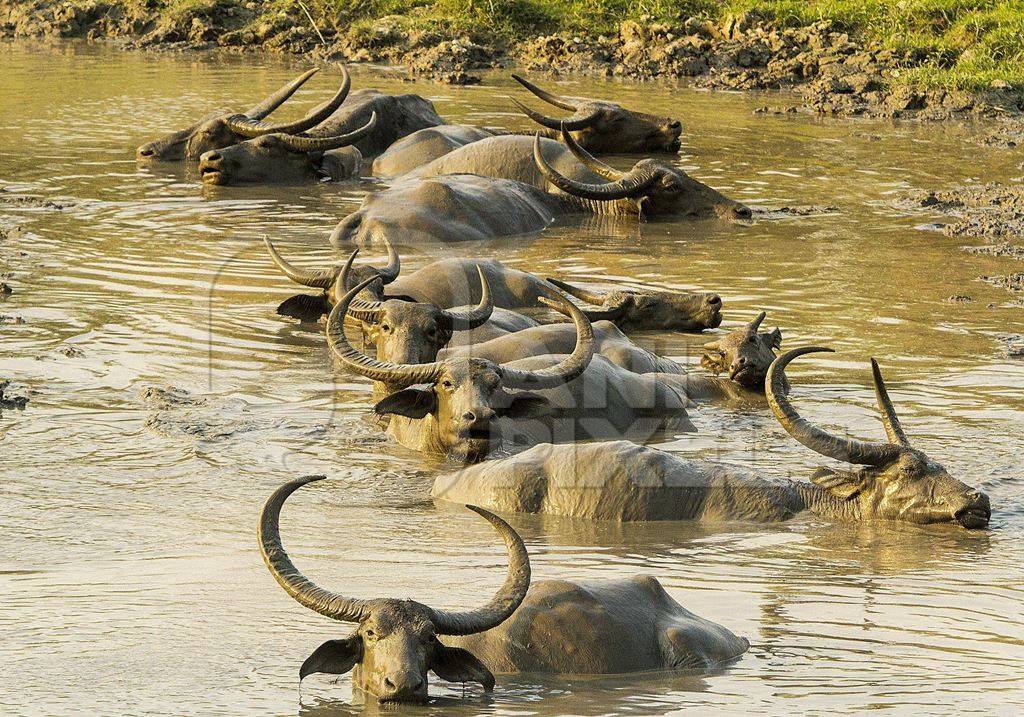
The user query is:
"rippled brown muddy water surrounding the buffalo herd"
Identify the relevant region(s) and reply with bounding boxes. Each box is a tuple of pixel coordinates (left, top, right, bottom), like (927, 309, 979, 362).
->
(0, 45, 1024, 715)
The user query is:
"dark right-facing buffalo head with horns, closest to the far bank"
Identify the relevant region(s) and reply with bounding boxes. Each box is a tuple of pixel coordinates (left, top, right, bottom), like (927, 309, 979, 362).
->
(512, 75, 682, 154)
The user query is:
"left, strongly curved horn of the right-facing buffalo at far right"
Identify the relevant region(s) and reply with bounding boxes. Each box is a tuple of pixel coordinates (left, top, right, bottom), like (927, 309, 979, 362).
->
(765, 346, 899, 466)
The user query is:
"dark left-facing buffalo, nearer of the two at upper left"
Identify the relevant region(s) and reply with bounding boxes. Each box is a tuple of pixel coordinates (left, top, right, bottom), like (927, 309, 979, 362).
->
(199, 114, 377, 184)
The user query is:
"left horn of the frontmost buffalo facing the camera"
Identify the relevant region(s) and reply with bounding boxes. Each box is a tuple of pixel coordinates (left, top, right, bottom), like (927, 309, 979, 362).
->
(258, 475, 369, 623)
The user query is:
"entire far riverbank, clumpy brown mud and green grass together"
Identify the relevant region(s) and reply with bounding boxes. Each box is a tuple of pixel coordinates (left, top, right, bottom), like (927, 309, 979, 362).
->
(6, 0, 1024, 120)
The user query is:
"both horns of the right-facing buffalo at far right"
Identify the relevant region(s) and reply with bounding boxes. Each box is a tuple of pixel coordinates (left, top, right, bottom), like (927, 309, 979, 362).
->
(765, 346, 910, 466)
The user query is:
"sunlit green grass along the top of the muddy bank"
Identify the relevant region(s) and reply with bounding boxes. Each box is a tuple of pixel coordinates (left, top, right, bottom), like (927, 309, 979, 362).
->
(274, 0, 1024, 89)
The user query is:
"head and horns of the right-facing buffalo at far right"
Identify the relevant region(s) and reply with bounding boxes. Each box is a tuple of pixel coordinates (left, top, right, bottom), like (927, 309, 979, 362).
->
(765, 346, 991, 528)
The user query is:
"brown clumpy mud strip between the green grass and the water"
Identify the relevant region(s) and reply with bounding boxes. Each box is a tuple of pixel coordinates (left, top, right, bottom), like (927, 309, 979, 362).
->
(0, 0, 1024, 121)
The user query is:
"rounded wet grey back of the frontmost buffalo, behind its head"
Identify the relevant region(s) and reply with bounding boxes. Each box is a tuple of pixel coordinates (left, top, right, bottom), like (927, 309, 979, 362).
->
(453, 576, 750, 675)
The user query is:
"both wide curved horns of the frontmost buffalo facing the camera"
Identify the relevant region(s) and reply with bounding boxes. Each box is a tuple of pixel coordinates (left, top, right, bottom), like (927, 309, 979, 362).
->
(258, 475, 530, 635)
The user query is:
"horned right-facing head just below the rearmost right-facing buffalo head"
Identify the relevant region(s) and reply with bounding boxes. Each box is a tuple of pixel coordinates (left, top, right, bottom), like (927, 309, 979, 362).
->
(534, 130, 751, 222)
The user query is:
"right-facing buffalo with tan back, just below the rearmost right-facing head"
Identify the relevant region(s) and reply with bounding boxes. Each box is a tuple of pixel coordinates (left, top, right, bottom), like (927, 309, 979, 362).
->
(409, 131, 751, 221)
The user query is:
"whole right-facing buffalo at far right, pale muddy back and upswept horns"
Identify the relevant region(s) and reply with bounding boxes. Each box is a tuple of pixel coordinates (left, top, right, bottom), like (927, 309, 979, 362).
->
(433, 347, 991, 529)
